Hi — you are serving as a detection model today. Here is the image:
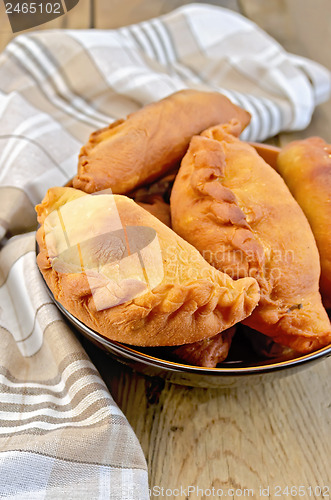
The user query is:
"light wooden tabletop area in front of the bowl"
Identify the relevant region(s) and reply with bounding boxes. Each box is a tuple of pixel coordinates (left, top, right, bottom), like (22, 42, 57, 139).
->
(84, 341, 331, 499)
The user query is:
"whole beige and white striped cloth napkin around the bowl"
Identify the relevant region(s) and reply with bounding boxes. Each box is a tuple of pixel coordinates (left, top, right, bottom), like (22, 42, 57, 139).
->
(0, 4, 330, 500)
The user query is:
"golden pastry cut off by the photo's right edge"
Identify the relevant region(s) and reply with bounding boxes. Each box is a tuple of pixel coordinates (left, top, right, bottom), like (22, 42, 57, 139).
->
(276, 137, 331, 308)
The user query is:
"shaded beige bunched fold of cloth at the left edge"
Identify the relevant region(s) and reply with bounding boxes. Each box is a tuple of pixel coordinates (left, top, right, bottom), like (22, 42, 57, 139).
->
(0, 186, 37, 239)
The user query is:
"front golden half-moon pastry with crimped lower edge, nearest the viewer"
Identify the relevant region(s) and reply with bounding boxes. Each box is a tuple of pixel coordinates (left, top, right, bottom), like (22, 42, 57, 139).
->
(36, 188, 259, 346)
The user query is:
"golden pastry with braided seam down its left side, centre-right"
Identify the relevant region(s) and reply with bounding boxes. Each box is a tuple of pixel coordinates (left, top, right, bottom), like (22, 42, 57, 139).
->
(170, 123, 331, 352)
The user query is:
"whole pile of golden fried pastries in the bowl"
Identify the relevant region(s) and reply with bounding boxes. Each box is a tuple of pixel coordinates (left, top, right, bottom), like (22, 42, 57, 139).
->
(36, 90, 331, 367)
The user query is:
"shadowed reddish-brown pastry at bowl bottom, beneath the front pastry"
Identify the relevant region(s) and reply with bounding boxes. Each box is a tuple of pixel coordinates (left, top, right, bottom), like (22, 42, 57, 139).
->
(173, 326, 236, 368)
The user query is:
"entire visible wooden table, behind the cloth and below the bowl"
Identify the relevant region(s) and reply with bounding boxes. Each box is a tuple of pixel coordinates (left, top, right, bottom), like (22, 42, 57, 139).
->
(0, 0, 331, 499)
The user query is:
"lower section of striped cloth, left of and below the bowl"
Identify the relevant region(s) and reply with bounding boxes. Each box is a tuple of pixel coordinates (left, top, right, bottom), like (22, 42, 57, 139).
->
(0, 233, 148, 500)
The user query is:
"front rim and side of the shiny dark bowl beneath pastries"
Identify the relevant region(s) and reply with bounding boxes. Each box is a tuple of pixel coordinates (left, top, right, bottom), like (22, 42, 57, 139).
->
(46, 285, 331, 388)
